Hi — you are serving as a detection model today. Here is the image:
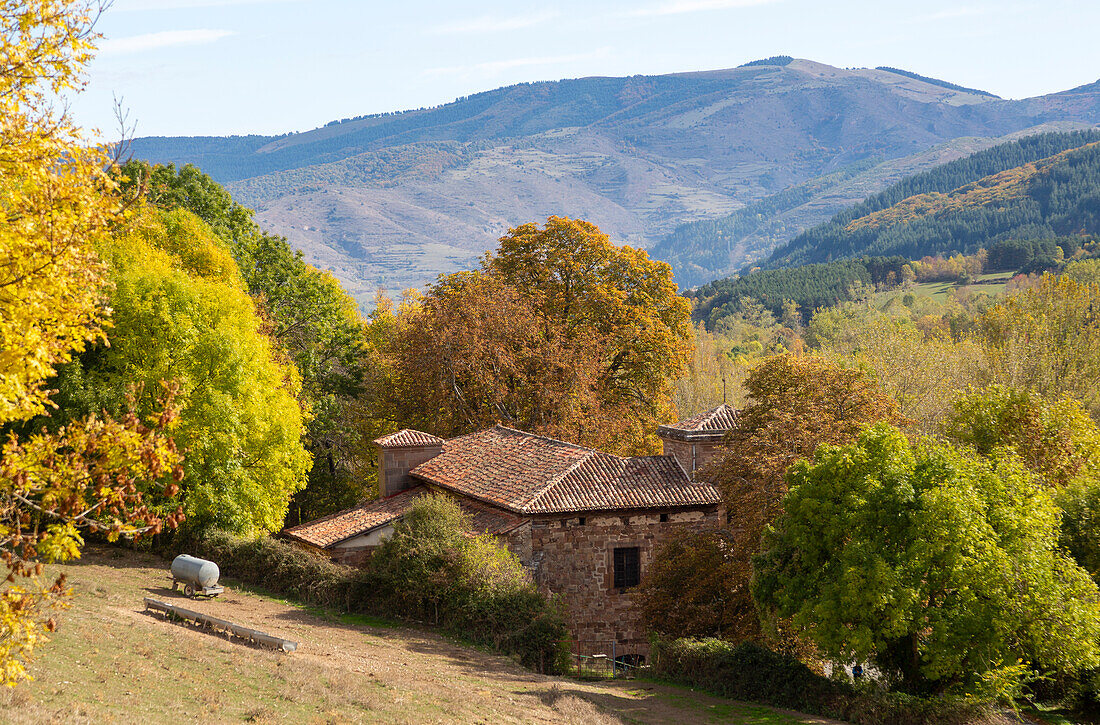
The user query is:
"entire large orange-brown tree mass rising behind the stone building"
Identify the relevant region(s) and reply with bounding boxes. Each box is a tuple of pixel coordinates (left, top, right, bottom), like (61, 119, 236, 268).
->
(393, 217, 691, 452)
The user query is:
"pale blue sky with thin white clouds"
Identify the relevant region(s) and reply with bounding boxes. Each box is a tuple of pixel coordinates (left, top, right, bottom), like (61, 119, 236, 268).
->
(72, 0, 1100, 138)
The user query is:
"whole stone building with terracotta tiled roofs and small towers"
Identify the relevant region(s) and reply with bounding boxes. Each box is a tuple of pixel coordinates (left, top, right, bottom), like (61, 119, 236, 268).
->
(283, 406, 736, 656)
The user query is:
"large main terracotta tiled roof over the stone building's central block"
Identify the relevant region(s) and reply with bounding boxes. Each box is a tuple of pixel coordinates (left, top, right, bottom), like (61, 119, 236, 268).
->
(410, 426, 718, 514)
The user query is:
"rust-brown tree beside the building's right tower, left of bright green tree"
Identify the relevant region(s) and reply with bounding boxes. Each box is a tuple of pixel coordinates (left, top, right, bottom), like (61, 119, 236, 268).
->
(686, 354, 902, 639)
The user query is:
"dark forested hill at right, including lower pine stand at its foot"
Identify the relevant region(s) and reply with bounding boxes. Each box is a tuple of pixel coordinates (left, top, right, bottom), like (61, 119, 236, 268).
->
(688, 131, 1100, 327)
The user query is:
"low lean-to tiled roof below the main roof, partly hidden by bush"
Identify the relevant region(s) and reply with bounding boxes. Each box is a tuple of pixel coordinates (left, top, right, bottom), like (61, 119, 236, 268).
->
(283, 486, 523, 549)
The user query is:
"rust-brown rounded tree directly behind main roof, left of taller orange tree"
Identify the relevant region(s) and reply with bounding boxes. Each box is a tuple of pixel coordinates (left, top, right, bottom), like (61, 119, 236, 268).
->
(391, 272, 617, 441)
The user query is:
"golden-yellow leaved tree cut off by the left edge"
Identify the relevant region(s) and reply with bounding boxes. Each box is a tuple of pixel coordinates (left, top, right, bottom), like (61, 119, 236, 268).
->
(0, 0, 182, 684)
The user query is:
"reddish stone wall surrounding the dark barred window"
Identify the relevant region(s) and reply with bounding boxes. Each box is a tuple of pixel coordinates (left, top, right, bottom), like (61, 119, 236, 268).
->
(508, 507, 718, 655)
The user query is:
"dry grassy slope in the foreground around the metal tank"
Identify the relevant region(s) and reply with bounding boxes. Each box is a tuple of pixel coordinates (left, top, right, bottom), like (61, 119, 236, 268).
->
(0, 548, 826, 725)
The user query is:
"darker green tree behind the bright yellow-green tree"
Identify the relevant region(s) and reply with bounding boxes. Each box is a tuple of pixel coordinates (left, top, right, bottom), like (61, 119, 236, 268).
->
(119, 161, 384, 525)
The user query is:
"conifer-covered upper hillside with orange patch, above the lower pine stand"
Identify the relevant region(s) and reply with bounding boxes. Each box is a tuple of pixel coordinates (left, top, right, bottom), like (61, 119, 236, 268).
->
(763, 131, 1100, 267)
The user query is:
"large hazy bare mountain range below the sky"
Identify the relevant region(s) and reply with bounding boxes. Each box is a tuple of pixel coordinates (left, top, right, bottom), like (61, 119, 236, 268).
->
(133, 56, 1100, 300)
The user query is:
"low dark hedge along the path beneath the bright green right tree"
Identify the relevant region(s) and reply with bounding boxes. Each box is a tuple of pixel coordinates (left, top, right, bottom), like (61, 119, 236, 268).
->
(651, 639, 989, 725)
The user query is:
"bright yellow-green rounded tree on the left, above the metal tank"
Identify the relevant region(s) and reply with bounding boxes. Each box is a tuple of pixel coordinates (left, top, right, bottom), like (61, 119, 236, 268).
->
(58, 210, 309, 532)
